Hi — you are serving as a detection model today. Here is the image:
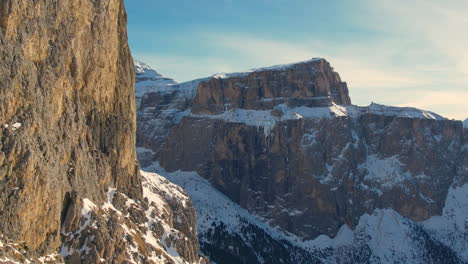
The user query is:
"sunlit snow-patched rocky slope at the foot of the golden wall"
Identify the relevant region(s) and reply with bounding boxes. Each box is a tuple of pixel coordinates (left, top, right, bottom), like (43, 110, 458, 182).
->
(0, 171, 206, 264)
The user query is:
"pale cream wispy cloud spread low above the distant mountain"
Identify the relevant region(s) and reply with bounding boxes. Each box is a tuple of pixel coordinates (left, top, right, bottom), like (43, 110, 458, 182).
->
(133, 0, 468, 119)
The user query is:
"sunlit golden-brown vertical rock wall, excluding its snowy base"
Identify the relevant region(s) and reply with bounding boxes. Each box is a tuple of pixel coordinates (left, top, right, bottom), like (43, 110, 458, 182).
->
(0, 0, 142, 254)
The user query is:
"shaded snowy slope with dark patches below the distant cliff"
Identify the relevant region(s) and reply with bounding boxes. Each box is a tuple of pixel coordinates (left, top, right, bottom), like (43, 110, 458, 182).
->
(144, 159, 468, 263)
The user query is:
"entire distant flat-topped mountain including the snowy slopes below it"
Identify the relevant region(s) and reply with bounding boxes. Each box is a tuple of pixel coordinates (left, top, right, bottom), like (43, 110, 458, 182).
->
(137, 59, 468, 263)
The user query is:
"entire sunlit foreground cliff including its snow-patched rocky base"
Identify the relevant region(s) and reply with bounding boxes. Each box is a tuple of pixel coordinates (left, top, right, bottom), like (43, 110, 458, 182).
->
(0, 0, 207, 263)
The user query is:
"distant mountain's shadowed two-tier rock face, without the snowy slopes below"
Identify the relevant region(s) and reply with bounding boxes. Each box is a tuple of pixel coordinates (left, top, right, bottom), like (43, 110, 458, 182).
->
(138, 59, 466, 242)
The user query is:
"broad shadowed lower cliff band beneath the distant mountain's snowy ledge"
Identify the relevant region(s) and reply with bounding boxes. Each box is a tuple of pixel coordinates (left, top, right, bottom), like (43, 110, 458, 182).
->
(159, 114, 462, 239)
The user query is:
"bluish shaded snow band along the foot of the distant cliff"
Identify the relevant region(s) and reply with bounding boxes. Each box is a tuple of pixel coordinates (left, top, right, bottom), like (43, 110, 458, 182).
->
(144, 159, 468, 263)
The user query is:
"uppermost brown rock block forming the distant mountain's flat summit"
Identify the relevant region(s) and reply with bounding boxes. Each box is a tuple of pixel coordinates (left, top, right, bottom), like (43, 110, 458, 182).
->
(192, 59, 351, 114)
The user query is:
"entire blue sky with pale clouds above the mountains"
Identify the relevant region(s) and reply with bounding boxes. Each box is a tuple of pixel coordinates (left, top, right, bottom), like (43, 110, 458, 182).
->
(125, 0, 468, 119)
